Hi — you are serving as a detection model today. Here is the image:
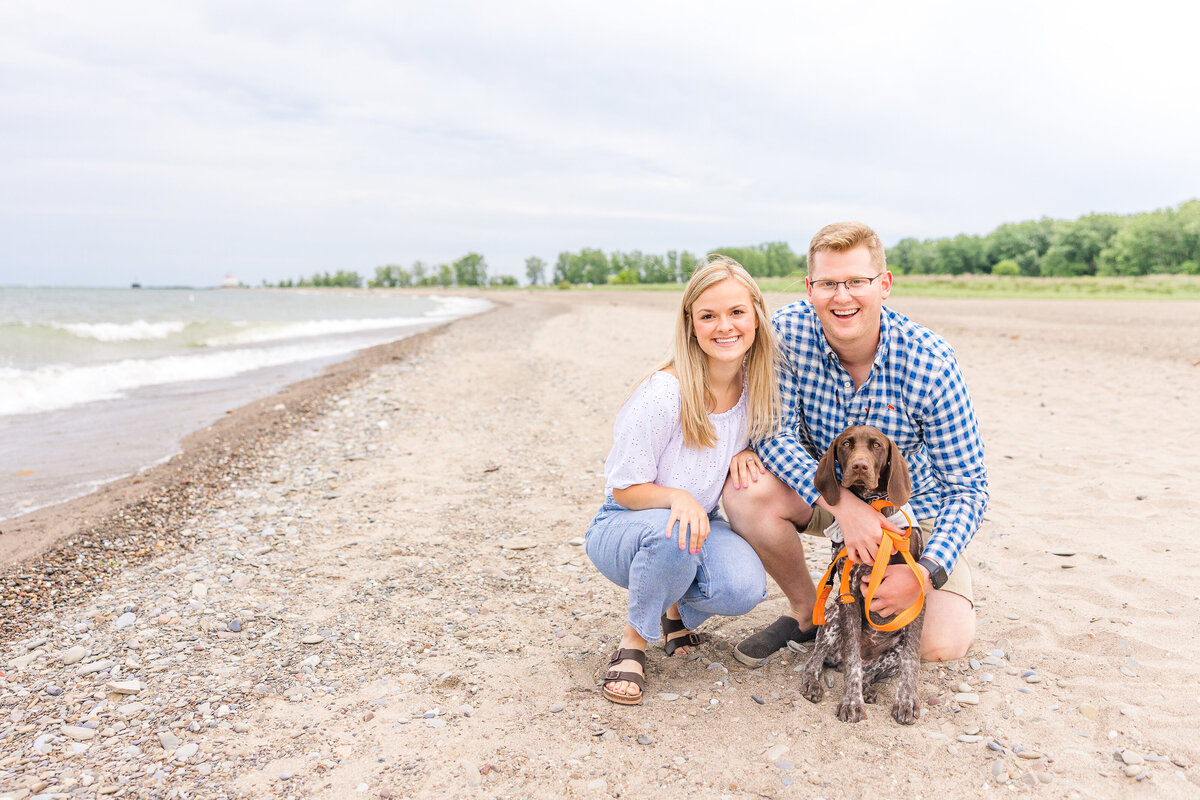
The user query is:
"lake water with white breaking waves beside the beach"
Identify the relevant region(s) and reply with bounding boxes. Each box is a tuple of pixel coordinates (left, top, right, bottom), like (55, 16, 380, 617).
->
(0, 287, 490, 519)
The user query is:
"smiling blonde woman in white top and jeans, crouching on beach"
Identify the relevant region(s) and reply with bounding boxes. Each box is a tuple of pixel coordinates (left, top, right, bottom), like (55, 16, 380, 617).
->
(587, 255, 779, 704)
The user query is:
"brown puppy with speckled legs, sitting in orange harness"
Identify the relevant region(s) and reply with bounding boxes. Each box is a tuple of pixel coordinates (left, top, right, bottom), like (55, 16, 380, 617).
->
(800, 426, 925, 724)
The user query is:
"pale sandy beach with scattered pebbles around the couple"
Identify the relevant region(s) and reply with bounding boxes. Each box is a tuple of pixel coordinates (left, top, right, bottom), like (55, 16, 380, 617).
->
(0, 289, 1200, 800)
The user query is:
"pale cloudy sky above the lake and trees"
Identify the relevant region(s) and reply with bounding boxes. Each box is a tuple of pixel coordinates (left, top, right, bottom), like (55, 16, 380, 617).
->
(0, 0, 1200, 285)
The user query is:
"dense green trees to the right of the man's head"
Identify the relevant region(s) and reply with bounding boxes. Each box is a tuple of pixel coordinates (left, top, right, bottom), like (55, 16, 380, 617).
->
(888, 199, 1200, 277)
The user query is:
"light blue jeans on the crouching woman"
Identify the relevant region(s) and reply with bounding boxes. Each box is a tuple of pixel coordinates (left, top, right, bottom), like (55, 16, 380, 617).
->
(587, 499, 767, 642)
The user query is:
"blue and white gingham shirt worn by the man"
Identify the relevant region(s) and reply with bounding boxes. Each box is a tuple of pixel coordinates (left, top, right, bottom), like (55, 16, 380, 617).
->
(754, 300, 988, 573)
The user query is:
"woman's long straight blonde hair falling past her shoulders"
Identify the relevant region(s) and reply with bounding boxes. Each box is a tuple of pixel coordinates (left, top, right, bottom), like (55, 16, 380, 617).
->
(652, 254, 780, 449)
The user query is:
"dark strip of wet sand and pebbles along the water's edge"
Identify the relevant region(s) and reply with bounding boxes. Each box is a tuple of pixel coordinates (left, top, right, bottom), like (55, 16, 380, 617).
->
(0, 302, 472, 642)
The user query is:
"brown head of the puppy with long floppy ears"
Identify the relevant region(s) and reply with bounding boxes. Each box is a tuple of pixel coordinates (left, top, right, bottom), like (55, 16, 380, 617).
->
(812, 425, 912, 506)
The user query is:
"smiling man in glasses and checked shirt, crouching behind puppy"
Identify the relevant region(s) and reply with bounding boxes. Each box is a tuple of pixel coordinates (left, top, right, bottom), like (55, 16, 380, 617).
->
(724, 222, 988, 667)
